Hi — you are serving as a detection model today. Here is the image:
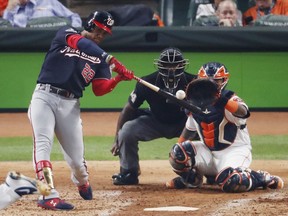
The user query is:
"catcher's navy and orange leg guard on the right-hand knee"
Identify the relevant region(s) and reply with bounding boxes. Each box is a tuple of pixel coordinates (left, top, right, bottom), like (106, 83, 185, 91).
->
(216, 167, 252, 193)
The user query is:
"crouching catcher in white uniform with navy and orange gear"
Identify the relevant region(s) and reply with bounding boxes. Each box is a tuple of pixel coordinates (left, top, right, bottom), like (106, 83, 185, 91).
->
(166, 62, 284, 193)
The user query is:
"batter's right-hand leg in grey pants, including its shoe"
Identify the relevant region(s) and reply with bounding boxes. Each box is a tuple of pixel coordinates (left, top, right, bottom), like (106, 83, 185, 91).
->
(55, 99, 92, 199)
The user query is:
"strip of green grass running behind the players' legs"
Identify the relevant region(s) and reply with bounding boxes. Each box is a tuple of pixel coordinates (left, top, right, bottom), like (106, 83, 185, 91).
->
(0, 135, 288, 161)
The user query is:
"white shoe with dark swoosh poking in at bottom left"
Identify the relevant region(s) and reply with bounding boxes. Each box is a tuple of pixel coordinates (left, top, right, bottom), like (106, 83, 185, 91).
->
(5, 171, 37, 196)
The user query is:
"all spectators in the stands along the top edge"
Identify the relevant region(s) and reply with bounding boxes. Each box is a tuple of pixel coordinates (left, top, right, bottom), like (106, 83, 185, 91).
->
(0, 0, 288, 28)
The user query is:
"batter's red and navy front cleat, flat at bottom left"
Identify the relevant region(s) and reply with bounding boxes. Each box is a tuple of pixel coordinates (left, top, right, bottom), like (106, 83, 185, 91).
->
(38, 198, 74, 211)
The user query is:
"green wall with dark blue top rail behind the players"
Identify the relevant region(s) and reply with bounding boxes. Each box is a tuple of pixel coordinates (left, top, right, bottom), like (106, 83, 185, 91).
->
(0, 0, 288, 112)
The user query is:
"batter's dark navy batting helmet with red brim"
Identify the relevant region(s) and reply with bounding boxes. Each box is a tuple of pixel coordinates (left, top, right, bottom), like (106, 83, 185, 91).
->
(84, 11, 114, 34)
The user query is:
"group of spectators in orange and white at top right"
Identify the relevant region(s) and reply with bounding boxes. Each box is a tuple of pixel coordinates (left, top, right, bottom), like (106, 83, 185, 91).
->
(191, 0, 288, 26)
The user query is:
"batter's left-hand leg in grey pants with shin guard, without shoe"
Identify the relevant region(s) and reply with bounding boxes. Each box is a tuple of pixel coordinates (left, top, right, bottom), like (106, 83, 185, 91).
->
(28, 91, 59, 199)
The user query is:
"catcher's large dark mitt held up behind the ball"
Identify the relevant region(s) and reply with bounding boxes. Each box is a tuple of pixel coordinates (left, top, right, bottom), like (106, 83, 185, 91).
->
(186, 78, 219, 109)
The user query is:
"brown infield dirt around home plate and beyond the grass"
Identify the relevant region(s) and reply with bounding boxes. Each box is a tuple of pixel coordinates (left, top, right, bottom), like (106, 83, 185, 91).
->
(0, 112, 288, 216)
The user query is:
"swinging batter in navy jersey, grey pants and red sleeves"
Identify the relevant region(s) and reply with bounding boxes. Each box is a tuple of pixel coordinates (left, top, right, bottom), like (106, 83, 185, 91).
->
(28, 11, 133, 210)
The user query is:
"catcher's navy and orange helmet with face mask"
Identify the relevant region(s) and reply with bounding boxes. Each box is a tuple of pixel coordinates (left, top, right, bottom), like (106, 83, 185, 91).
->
(198, 62, 230, 91)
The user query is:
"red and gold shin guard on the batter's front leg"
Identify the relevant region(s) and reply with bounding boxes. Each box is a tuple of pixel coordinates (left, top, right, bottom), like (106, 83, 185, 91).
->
(36, 160, 54, 188)
